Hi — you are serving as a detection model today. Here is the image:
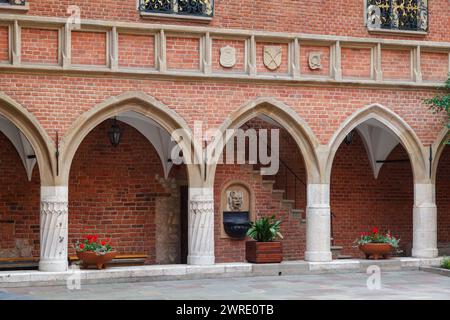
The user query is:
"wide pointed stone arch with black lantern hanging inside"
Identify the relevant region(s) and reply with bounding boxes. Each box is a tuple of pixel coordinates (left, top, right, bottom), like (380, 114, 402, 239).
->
(60, 92, 201, 185)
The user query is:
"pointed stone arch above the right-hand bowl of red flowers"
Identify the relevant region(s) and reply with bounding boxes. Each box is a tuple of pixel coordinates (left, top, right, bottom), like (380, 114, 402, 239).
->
(325, 104, 428, 183)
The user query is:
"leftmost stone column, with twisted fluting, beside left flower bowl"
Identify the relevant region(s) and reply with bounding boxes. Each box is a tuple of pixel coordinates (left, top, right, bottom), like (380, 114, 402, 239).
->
(39, 186, 68, 271)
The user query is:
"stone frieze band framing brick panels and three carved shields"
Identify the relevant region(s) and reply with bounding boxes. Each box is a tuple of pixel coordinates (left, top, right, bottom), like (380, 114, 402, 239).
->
(0, 14, 450, 87)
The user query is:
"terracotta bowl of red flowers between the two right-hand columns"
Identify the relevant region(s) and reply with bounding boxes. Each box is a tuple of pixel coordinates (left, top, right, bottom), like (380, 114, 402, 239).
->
(355, 227, 400, 260)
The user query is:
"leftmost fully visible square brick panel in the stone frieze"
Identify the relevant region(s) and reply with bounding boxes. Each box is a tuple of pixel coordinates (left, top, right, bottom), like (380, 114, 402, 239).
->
(21, 28, 59, 64)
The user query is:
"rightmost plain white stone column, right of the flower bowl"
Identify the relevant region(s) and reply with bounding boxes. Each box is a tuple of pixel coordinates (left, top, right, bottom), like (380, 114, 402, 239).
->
(412, 183, 438, 258)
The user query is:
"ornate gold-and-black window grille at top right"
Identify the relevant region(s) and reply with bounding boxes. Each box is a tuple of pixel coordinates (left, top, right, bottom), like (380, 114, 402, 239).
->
(367, 0, 428, 31)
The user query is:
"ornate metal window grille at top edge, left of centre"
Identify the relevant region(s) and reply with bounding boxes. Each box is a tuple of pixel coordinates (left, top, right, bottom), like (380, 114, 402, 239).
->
(139, 0, 214, 17)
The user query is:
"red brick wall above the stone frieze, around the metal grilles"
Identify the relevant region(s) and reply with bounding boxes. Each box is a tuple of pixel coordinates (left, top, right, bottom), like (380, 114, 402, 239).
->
(23, 0, 450, 41)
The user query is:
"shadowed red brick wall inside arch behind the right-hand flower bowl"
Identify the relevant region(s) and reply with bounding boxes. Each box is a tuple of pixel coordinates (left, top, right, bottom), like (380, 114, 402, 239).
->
(331, 134, 414, 257)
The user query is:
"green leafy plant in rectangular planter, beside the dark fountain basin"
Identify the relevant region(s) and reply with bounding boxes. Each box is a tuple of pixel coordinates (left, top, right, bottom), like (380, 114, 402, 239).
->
(245, 216, 283, 263)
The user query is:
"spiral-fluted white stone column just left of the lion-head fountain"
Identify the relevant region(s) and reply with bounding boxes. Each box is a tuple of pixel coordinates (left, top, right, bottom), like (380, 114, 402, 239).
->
(187, 188, 214, 265)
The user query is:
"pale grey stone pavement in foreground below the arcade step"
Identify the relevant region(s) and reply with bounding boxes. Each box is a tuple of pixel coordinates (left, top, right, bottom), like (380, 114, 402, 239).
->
(0, 271, 450, 300)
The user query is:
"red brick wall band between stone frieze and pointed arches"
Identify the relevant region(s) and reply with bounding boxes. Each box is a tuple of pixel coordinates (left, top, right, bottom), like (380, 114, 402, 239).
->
(0, 74, 444, 145)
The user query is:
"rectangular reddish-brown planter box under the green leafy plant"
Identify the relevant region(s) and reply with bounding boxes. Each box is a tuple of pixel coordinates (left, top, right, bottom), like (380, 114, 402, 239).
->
(245, 241, 283, 263)
